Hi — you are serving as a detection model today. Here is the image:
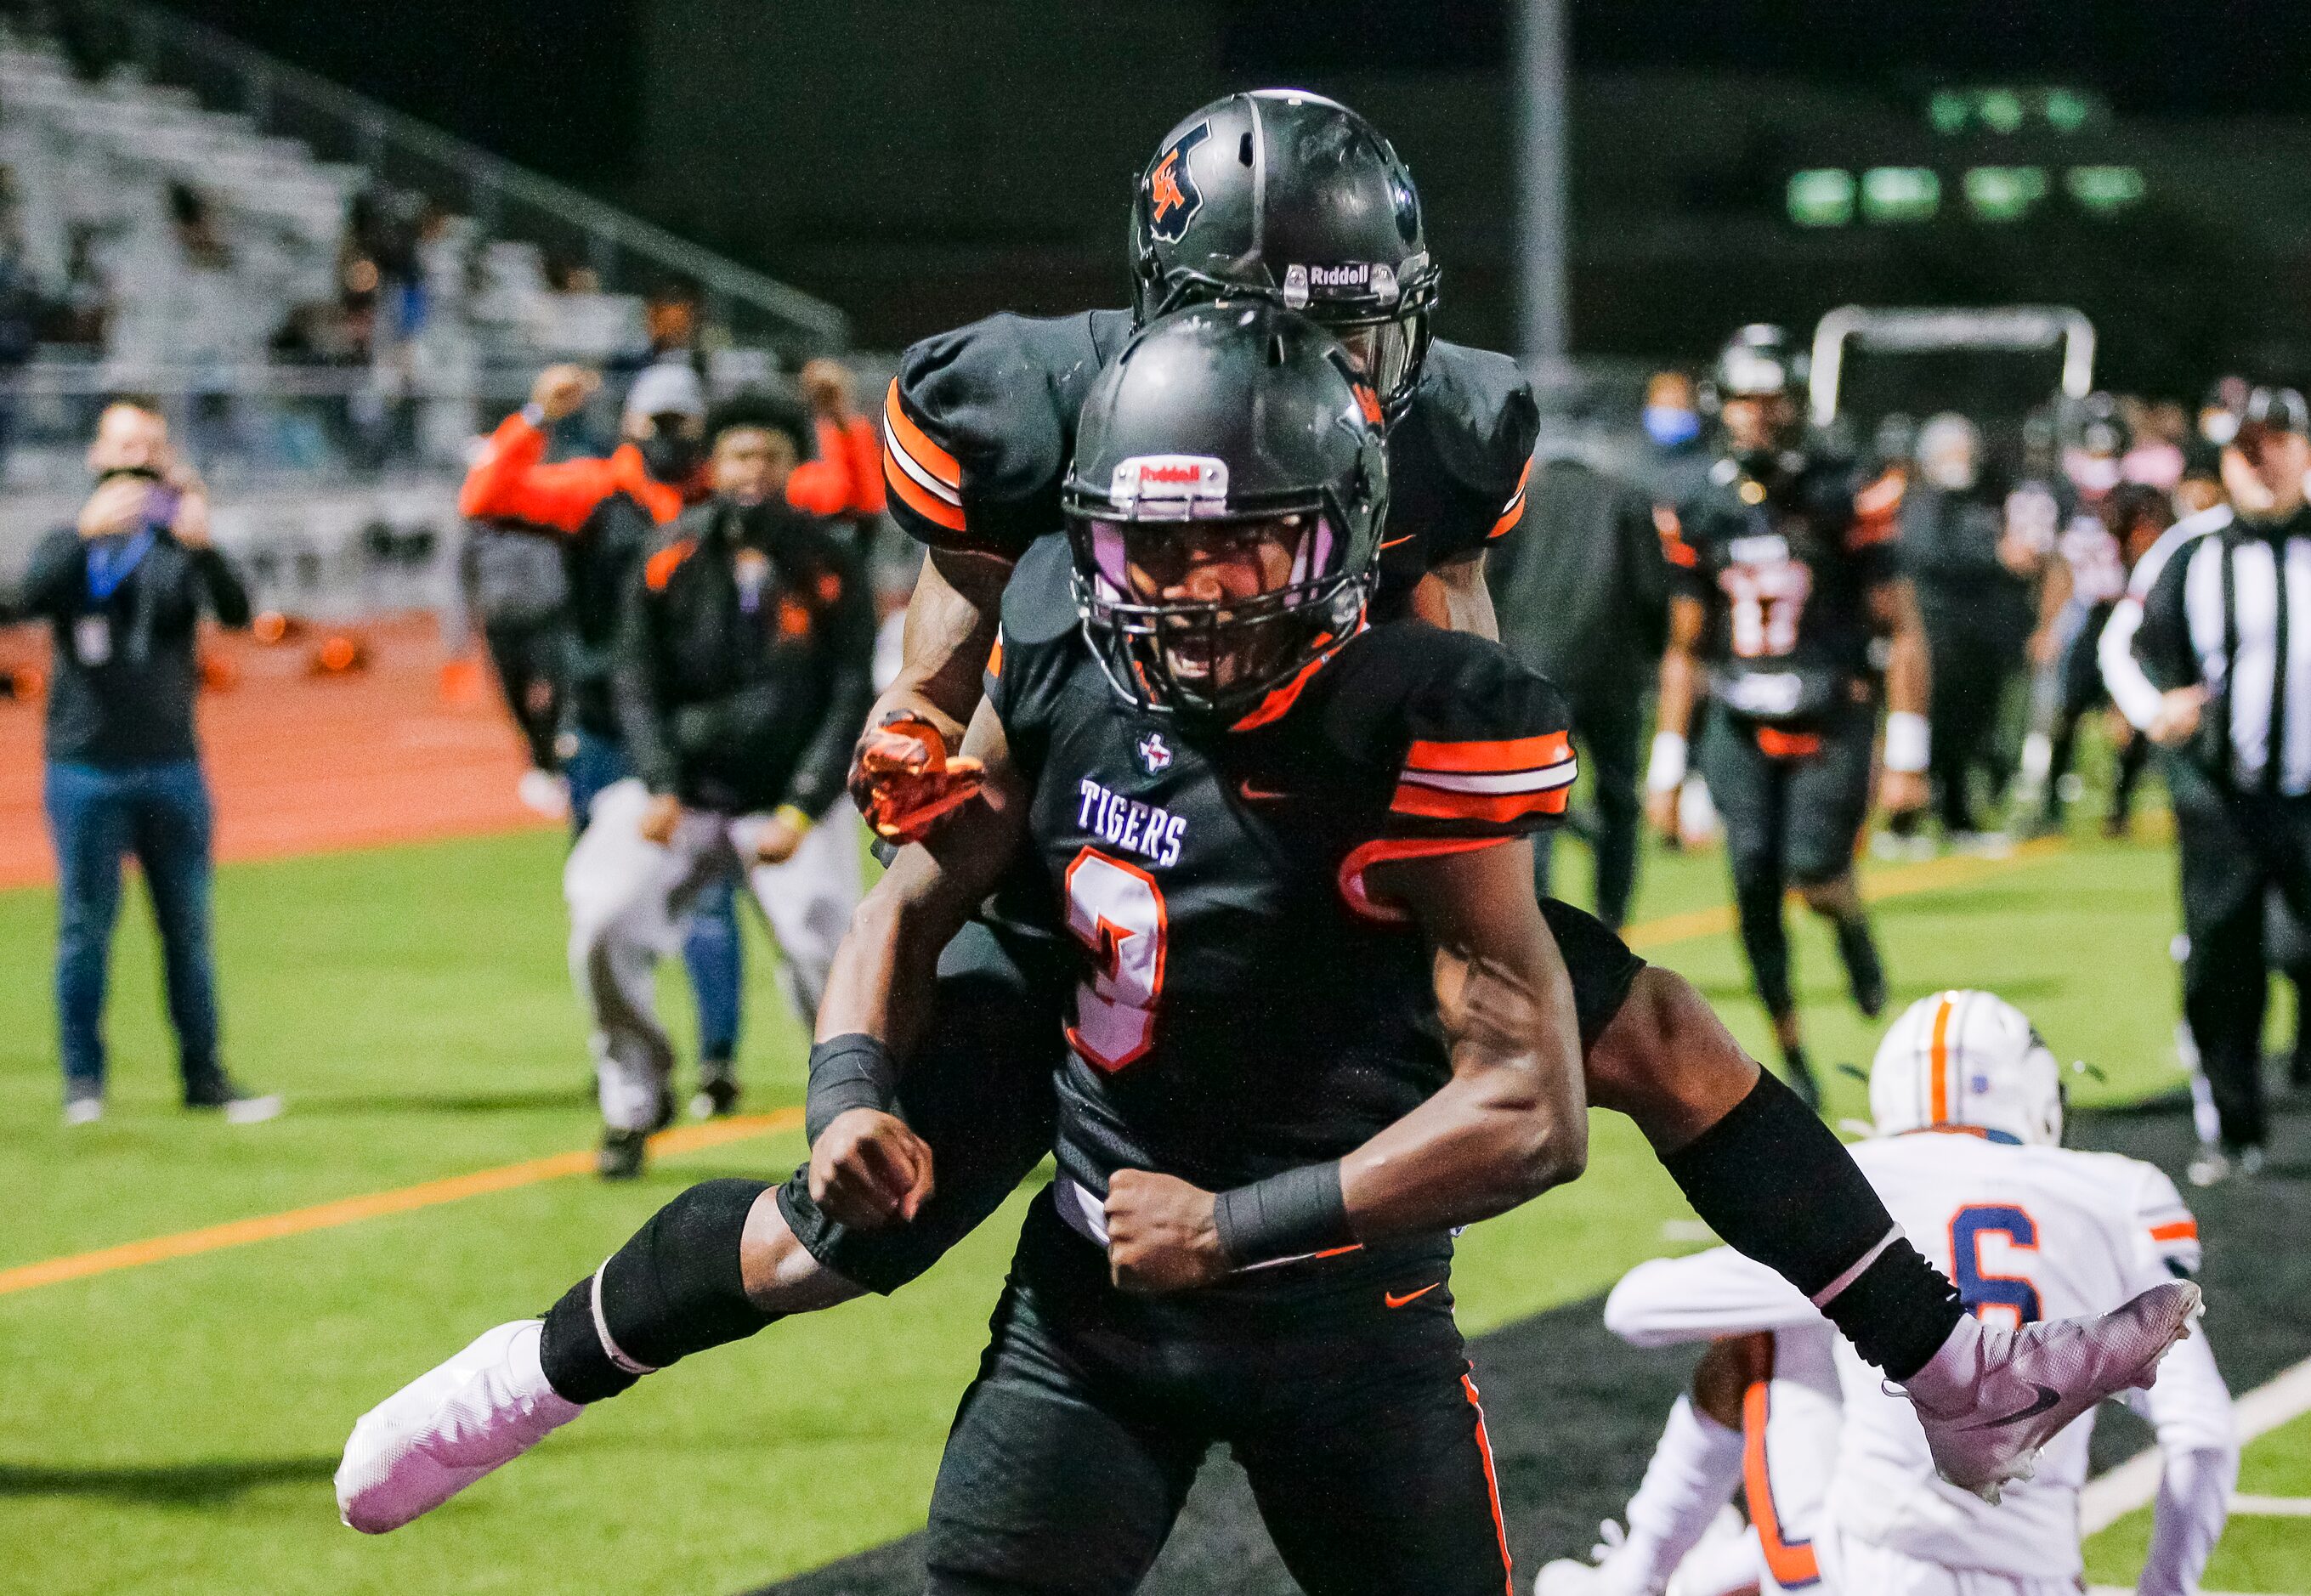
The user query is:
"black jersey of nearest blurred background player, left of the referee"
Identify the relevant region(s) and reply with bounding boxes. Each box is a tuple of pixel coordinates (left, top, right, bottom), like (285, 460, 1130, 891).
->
(1659, 455, 1902, 721)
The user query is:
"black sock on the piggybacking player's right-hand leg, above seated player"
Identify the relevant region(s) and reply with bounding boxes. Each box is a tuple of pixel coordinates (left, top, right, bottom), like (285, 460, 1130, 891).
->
(1662, 1072, 1962, 1379)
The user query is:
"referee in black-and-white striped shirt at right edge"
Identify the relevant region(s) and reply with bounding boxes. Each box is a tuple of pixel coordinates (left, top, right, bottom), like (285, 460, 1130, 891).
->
(2103, 388, 2311, 1185)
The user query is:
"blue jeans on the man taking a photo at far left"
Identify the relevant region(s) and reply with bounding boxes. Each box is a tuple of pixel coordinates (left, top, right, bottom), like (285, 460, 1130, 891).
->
(42, 760, 218, 1095)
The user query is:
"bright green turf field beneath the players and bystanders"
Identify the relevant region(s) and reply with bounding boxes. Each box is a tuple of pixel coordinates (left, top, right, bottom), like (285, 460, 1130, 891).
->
(0, 818, 2311, 1593)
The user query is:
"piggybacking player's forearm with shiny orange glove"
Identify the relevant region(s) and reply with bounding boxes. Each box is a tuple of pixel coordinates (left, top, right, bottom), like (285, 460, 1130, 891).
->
(851, 550, 1012, 843)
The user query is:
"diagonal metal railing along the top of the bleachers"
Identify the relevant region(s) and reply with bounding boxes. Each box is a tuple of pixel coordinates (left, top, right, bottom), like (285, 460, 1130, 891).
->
(63, 0, 848, 363)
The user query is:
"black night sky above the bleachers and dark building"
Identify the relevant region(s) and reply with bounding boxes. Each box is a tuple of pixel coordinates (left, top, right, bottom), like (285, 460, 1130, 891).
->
(185, 0, 2311, 180)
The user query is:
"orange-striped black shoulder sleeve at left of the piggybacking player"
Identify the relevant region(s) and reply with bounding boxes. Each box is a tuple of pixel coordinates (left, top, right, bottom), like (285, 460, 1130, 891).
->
(883, 312, 1128, 559)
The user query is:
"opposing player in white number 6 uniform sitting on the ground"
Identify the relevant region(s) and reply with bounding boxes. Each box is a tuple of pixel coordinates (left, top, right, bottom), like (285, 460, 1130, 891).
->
(1537, 991, 2240, 1596)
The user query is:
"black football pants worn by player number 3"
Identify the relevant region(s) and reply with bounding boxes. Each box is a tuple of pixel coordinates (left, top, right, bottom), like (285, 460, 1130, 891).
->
(925, 1194, 1514, 1596)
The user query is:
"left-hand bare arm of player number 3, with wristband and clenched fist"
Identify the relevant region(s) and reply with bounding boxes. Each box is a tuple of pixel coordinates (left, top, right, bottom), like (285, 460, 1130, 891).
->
(811, 705, 1026, 1229)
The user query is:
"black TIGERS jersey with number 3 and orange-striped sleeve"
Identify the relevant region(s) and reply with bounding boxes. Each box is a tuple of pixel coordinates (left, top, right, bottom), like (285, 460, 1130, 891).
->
(987, 605, 1574, 1194)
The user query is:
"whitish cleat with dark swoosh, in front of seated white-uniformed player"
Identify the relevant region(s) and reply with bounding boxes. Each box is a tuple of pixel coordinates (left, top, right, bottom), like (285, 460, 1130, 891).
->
(1906, 1280, 2200, 1502)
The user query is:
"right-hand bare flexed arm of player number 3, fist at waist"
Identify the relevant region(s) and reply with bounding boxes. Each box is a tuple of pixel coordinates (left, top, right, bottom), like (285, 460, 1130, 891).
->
(1107, 840, 1588, 1291)
